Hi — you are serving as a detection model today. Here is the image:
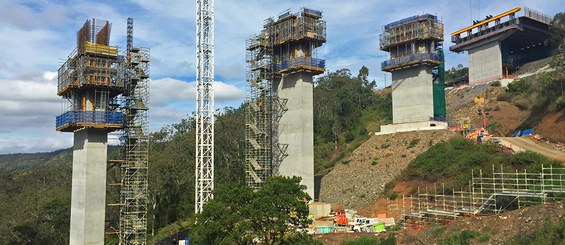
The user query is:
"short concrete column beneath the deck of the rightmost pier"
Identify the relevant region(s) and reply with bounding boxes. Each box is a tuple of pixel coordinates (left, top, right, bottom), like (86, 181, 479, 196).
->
(469, 41, 502, 83)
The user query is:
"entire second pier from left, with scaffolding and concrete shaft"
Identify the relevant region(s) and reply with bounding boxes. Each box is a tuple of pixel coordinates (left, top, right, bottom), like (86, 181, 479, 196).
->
(245, 8, 326, 198)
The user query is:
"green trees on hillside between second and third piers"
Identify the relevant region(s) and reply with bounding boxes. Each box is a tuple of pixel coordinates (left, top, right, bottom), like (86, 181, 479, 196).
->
(314, 67, 392, 172)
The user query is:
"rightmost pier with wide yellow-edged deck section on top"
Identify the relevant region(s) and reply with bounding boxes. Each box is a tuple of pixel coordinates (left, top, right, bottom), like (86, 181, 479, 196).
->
(449, 7, 552, 84)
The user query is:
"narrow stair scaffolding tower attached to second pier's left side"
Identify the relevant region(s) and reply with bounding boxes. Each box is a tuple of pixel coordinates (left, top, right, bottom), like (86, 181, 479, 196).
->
(245, 18, 274, 189)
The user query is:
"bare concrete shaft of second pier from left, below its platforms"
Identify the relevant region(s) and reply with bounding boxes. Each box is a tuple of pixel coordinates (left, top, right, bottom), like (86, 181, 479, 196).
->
(273, 72, 314, 198)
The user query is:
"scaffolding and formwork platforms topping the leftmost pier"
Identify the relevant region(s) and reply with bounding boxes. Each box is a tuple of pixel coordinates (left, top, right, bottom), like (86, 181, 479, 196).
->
(56, 19, 124, 132)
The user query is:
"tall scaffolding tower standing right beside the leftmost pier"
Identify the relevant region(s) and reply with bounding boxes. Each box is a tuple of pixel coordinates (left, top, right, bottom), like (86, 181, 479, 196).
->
(119, 18, 150, 244)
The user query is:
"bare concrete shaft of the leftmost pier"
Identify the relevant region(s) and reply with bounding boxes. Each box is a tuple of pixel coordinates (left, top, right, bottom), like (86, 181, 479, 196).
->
(70, 128, 108, 244)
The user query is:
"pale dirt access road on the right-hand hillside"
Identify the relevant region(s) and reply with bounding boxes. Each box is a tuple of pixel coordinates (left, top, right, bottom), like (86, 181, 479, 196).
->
(496, 137, 565, 162)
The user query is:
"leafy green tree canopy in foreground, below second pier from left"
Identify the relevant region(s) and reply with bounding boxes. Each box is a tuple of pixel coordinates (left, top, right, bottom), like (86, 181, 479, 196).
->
(191, 176, 313, 244)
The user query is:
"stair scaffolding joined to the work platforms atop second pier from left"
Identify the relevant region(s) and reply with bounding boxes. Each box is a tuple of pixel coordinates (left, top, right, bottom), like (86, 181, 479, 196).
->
(245, 8, 326, 189)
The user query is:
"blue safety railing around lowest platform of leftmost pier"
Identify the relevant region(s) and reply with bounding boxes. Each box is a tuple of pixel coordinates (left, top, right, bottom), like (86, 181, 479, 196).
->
(56, 111, 124, 128)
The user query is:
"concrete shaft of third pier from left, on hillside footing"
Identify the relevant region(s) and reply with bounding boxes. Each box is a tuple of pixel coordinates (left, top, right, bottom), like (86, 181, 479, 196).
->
(392, 66, 434, 124)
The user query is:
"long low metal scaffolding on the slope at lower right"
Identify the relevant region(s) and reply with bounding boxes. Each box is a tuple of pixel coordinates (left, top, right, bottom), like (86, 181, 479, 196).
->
(387, 166, 565, 227)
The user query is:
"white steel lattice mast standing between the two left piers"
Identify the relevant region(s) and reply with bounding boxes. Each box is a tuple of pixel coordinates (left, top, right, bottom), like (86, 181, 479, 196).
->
(195, 0, 214, 213)
